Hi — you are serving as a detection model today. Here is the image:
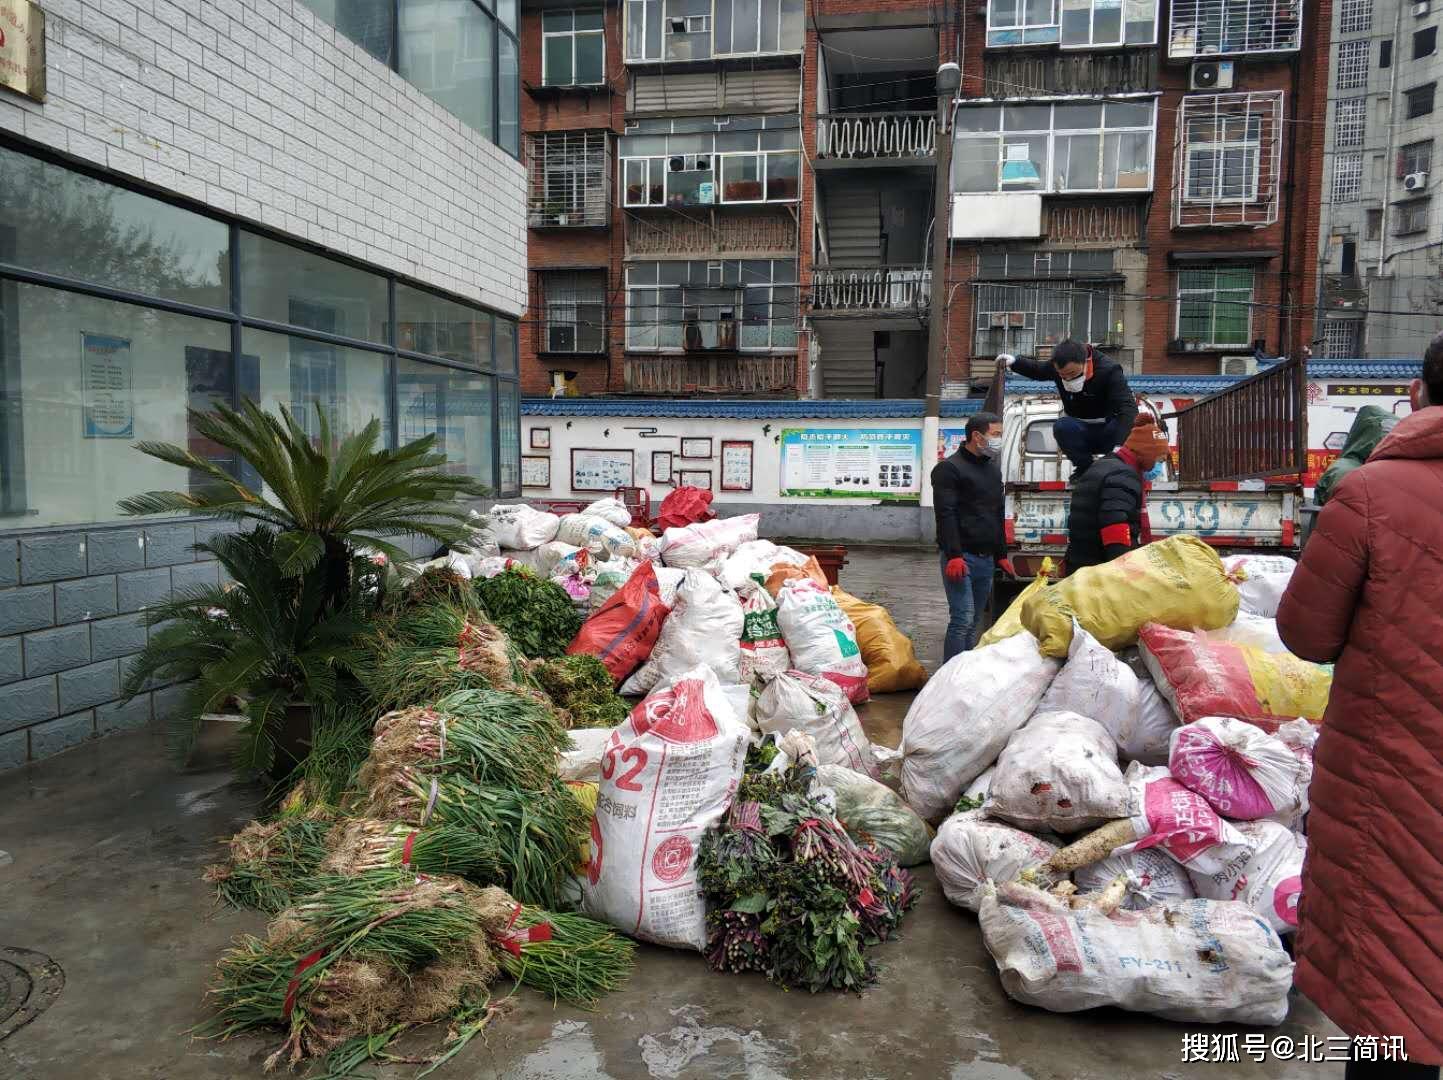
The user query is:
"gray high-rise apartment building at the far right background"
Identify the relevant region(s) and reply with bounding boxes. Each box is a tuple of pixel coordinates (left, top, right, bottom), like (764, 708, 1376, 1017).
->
(1316, 0, 1443, 358)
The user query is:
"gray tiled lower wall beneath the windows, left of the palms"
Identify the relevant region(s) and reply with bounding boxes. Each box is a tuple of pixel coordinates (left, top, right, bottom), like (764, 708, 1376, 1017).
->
(0, 521, 228, 770)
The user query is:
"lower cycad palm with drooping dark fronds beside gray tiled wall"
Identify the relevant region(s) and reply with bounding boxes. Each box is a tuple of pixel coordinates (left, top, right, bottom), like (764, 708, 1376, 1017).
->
(124, 528, 368, 771)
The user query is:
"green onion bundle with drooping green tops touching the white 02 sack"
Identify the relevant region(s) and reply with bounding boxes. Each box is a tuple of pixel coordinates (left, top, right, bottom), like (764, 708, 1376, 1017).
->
(368, 768, 592, 908)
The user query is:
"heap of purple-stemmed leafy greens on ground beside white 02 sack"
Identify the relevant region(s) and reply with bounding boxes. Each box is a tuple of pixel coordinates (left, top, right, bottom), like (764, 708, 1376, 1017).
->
(697, 767, 916, 993)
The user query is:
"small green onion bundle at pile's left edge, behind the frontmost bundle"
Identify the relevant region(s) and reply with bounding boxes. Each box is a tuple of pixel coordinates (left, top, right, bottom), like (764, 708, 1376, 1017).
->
(205, 813, 330, 913)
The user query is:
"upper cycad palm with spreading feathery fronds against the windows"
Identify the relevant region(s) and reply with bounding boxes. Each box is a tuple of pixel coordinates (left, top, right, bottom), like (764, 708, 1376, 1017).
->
(120, 401, 488, 611)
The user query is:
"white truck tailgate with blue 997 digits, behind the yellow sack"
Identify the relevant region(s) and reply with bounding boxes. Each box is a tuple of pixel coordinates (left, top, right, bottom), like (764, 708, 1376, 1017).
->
(1007, 487, 1296, 550)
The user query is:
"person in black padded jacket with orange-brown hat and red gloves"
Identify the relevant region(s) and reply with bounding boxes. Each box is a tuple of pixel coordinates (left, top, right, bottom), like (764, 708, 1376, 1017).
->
(1066, 413, 1167, 573)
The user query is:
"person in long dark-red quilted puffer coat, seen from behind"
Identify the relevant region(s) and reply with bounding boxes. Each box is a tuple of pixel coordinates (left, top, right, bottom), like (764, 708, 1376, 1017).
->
(1277, 334, 1443, 1080)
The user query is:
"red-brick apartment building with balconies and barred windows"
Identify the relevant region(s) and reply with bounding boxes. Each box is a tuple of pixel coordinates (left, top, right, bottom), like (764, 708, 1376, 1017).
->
(522, 0, 1330, 399)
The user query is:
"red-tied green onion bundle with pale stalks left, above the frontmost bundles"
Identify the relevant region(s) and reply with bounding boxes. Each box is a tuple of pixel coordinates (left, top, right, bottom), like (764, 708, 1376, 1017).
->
(320, 817, 502, 885)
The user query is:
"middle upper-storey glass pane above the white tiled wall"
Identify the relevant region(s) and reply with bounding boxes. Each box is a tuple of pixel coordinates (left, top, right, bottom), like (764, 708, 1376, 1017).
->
(398, 0, 496, 137)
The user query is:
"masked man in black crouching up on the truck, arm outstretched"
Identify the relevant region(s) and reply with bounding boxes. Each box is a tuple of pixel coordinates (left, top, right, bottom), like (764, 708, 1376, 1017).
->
(997, 338, 1137, 475)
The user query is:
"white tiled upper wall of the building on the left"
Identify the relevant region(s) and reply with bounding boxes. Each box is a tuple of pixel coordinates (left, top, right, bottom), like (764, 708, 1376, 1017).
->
(0, 0, 527, 315)
